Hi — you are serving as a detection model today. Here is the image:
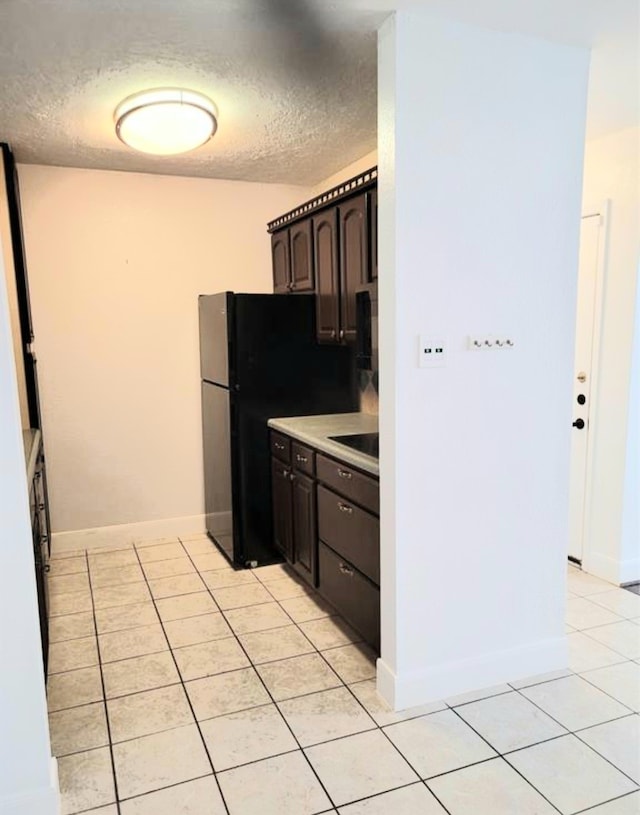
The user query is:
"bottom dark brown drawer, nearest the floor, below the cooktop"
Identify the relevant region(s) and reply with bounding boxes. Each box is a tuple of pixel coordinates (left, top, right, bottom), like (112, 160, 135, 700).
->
(318, 541, 380, 652)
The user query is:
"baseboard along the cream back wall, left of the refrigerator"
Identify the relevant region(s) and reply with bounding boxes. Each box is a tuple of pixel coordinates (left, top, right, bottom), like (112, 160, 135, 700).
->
(51, 515, 205, 554)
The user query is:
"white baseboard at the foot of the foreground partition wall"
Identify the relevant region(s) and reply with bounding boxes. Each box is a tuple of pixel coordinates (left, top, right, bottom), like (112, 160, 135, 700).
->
(377, 637, 568, 710)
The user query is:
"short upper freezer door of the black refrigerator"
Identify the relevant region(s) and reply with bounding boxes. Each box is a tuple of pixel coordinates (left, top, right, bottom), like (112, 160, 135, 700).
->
(198, 292, 233, 387)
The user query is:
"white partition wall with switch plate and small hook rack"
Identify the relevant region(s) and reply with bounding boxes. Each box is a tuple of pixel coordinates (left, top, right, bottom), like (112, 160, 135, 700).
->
(378, 11, 588, 707)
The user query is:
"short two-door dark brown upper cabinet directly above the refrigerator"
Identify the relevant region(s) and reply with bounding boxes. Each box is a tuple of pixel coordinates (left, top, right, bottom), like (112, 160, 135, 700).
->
(271, 218, 315, 294)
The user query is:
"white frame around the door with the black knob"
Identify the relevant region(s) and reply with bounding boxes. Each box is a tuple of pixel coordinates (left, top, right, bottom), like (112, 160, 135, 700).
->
(573, 198, 611, 572)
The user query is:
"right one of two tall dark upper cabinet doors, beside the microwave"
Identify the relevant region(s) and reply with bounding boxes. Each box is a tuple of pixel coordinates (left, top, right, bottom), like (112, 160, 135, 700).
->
(340, 193, 369, 342)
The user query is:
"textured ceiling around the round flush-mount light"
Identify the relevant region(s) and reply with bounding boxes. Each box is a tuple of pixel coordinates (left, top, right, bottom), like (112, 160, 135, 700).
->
(0, 0, 640, 185)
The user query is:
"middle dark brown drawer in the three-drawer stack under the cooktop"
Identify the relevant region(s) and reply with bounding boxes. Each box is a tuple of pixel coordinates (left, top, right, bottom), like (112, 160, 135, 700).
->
(318, 487, 380, 585)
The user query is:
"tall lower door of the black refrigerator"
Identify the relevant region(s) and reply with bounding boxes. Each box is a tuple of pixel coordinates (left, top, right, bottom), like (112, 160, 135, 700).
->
(202, 382, 234, 562)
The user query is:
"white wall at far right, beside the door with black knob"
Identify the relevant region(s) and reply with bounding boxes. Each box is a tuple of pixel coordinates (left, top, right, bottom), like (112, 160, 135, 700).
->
(583, 128, 640, 583)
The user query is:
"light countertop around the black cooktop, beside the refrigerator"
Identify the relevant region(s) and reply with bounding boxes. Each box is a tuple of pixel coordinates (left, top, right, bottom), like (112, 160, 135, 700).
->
(268, 413, 380, 476)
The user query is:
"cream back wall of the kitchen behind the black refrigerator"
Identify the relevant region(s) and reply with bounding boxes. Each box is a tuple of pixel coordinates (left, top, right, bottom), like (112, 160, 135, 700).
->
(19, 165, 309, 542)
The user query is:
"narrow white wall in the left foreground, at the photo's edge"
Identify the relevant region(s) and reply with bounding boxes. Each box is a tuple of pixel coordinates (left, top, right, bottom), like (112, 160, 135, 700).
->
(0, 236, 58, 815)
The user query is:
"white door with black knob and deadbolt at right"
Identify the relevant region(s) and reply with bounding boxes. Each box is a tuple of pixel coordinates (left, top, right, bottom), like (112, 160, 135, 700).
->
(569, 214, 602, 562)
